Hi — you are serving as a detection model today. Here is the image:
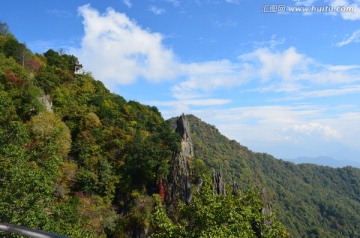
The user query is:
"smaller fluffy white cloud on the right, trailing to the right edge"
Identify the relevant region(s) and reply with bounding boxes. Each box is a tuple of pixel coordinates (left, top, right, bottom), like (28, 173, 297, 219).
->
(239, 47, 360, 85)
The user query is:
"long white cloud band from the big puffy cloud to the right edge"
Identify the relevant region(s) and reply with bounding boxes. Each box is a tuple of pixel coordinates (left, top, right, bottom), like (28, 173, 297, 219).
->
(172, 47, 360, 100)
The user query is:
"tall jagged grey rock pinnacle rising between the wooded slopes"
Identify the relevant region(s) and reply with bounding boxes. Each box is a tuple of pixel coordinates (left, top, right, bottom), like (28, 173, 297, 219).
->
(166, 114, 194, 205)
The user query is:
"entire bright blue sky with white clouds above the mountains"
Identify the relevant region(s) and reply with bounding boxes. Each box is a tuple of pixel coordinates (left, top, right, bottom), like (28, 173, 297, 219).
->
(0, 0, 360, 166)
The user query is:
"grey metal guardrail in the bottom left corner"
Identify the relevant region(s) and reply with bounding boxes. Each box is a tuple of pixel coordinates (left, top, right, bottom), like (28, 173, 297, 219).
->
(0, 222, 69, 238)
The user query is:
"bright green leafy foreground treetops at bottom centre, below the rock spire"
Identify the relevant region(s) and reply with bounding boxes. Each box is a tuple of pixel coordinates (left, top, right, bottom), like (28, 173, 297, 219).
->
(151, 178, 289, 238)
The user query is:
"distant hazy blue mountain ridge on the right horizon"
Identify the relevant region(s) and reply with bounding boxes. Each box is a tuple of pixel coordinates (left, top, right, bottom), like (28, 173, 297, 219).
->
(289, 156, 360, 168)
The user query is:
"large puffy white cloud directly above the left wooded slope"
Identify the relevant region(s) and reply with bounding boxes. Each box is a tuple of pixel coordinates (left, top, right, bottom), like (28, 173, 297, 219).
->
(73, 5, 177, 87)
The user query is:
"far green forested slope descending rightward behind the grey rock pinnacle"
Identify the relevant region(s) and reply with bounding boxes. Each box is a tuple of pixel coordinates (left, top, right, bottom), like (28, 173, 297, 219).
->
(171, 116, 360, 237)
